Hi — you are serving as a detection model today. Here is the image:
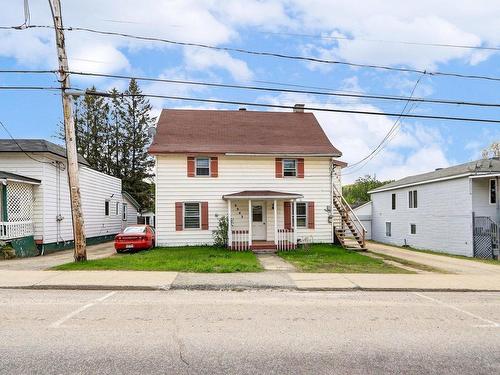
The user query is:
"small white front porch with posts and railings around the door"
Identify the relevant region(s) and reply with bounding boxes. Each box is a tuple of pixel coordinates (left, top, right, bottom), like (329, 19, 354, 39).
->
(223, 190, 303, 252)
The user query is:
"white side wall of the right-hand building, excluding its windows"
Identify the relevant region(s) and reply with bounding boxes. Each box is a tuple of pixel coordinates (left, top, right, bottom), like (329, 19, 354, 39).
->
(371, 177, 472, 256)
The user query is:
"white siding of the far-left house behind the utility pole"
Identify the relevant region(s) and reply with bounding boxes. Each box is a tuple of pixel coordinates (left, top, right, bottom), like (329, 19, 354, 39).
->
(0, 153, 122, 244)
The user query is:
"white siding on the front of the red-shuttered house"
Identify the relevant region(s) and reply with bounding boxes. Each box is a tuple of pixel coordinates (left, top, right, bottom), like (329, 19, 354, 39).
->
(155, 154, 341, 246)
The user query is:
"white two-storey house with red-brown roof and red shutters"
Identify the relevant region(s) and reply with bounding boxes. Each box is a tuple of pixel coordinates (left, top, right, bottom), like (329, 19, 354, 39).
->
(149, 105, 364, 250)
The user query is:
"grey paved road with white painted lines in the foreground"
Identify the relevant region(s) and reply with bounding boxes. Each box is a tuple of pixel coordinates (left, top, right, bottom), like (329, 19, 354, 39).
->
(0, 290, 500, 374)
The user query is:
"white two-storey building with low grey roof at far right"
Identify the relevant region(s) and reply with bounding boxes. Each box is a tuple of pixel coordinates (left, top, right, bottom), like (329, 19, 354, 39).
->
(365, 158, 500, 258)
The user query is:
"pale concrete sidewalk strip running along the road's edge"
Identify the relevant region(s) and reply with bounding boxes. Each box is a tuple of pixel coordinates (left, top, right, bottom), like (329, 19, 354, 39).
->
(0, 270, 500, 292)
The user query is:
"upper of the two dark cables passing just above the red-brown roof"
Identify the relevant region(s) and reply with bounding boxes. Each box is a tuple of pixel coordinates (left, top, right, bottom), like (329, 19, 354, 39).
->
(0, 70, 500, 107)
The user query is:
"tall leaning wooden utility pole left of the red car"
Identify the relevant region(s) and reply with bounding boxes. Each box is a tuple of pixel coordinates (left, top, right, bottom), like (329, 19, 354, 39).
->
(48, 0, 87, 262)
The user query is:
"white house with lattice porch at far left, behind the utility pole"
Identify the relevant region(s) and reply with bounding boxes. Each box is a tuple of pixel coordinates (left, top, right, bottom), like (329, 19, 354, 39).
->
(0, 139, 137, 255)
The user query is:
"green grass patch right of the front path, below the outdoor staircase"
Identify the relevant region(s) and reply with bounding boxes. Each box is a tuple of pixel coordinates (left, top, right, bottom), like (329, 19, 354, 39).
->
(278, 244, 413, 273)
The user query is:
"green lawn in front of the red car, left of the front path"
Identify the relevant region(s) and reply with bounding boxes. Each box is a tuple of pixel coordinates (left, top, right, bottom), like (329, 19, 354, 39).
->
(54, 246, 262, 272)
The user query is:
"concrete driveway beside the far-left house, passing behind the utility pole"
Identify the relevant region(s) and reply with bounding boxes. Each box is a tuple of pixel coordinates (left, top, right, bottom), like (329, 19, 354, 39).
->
(0, 242, 115, 271)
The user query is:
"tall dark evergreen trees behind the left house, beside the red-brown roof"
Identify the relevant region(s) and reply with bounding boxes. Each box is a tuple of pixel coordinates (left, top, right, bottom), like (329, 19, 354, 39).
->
(56, 80, 155, 209)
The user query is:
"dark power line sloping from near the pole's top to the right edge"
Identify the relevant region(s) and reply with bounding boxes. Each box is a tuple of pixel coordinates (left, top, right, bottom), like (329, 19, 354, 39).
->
(10, 25, 500, 81)
